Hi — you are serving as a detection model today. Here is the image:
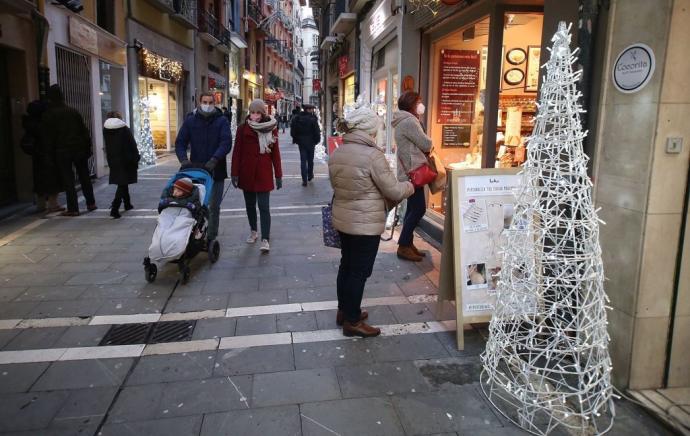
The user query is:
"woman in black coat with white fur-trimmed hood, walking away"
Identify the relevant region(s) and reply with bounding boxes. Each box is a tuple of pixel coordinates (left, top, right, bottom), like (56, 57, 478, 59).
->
(103, 112, 140, 219)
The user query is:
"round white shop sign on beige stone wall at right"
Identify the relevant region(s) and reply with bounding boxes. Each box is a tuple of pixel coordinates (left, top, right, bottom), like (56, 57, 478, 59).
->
(613, 43, 656, 94)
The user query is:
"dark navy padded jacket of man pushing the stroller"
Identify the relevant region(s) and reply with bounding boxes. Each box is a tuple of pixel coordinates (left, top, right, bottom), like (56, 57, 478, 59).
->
(175, 108, 232, 180)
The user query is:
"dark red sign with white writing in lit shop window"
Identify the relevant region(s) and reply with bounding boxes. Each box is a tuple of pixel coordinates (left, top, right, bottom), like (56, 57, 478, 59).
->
(436, 50, 479, 124)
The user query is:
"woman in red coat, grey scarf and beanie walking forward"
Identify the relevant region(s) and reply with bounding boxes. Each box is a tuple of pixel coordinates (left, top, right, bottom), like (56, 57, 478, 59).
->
(230, 100, 283, 253)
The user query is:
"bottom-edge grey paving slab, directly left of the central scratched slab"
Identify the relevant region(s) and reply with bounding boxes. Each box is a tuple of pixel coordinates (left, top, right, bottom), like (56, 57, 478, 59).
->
(201, 406, 302, 436)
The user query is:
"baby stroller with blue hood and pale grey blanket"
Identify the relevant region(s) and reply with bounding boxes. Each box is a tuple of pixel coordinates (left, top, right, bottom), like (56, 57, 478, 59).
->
(144, 168, 220, 284)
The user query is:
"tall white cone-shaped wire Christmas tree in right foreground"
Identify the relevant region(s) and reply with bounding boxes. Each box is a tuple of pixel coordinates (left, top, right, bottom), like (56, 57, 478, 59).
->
(481, 22, 615, 435)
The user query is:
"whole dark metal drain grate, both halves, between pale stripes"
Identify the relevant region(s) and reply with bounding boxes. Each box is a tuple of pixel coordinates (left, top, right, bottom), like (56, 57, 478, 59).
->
(98, 321, 196, 346)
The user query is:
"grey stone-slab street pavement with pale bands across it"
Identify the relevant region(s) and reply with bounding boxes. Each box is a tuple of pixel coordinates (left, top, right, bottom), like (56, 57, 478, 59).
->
(0, 135, 667, 436)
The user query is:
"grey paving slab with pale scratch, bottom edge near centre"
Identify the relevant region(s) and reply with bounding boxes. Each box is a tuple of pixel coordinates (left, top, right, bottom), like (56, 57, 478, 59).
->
(300, 398, 404, 436)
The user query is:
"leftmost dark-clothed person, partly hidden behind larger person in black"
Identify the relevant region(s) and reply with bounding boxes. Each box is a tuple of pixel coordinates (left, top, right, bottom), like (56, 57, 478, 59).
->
(20, 100, 65, 213)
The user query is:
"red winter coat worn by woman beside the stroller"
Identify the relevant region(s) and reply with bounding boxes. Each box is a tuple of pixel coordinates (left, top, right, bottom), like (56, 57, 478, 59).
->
(230, 123, 283, 192)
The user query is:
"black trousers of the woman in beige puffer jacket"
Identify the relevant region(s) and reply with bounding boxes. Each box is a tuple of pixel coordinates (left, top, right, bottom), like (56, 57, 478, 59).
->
(337, 232, 381, 323)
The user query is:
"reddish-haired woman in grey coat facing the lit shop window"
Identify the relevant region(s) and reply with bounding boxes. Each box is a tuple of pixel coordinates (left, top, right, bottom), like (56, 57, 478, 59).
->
(392, 91, 432, 262)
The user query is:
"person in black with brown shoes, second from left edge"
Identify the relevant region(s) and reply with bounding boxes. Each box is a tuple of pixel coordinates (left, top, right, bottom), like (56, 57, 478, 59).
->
(42, 84, 98, 216)
